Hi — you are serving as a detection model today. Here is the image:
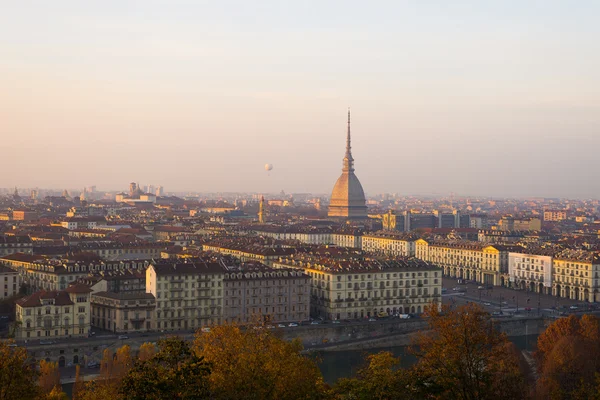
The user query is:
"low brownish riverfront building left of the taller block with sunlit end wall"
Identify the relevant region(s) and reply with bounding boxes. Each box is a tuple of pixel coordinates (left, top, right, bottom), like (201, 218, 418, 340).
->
(91, 292, 156, 333)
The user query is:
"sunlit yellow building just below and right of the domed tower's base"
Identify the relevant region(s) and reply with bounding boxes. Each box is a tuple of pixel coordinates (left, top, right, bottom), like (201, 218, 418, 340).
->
(361, 231, 419, 257)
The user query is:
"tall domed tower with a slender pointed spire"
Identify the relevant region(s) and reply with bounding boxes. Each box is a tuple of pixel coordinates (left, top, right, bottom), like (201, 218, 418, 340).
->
(328, 110, 367, 219)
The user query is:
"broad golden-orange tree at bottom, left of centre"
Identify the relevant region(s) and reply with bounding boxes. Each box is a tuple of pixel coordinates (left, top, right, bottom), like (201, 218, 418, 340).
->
(194, 324, 325, 400)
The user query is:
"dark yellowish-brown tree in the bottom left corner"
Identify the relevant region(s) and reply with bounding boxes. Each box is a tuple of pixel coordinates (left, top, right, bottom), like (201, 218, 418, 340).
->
(0, 341, 40, 400)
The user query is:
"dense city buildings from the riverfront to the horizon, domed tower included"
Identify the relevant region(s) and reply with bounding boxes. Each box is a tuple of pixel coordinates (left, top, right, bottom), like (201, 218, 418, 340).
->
(0, 114, 600, 352)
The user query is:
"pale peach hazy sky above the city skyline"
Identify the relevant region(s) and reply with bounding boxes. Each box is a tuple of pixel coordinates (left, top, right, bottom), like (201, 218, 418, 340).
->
(0, 0, 600, 197)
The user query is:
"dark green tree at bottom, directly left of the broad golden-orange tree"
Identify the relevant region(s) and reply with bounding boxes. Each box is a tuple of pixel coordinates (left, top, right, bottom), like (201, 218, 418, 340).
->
(119, 337, 210, 400)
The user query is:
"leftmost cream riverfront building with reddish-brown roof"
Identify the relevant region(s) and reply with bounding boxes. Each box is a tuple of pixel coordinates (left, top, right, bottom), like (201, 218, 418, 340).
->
(16, 284, 91, 340)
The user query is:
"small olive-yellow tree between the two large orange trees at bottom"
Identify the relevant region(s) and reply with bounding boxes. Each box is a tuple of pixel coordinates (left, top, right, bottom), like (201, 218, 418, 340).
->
(332, 352, 416, 400)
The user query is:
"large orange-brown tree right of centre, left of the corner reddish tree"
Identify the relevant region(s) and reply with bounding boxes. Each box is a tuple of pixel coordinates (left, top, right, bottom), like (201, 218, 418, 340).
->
(411, 303, 528, 400)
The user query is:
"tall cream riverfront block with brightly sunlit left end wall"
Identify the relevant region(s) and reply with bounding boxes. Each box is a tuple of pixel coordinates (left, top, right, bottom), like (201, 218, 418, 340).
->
(146, 259, 226, 331)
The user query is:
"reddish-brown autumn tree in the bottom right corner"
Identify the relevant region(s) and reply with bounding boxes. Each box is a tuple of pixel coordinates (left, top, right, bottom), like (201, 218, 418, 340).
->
(536, 315, 600, 399)
